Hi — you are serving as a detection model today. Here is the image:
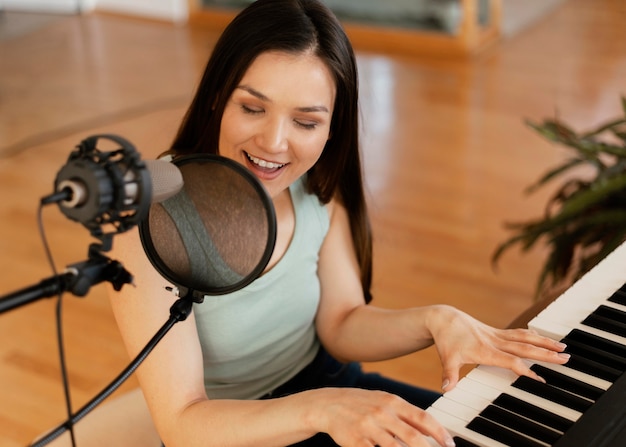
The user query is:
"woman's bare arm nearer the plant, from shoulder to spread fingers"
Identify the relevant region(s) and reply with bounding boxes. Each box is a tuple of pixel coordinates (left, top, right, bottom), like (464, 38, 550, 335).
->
(316, 203, 568, 388)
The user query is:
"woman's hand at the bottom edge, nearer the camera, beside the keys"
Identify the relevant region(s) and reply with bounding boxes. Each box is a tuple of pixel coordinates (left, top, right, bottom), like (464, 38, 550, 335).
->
(304, 388, 455, 447)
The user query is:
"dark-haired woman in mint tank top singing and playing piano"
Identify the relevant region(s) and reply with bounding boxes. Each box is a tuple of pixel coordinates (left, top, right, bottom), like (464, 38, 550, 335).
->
(111, 0, 567, 447)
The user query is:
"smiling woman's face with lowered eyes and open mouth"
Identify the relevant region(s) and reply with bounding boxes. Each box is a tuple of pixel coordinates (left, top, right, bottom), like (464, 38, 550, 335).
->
(219, 51, 335, 198)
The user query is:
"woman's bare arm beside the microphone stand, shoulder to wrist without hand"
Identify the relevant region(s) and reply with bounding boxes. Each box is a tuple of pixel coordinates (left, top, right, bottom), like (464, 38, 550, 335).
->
(111, 232, 315, 447)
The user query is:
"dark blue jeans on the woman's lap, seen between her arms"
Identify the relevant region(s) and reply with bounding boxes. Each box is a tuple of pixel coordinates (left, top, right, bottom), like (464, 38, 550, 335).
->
(263, 348, 441, 447)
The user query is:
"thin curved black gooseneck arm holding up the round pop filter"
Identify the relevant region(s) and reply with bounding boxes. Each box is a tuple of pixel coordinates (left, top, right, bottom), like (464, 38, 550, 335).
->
(30, 290, 195, 447)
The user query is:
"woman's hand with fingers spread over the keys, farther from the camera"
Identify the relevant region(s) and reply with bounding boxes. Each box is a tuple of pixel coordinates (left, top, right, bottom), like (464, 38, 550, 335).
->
(427, 305, 570, 391)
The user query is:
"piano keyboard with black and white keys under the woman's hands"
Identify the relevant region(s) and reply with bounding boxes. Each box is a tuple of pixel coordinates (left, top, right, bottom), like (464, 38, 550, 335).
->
(427, 244, 626, 447)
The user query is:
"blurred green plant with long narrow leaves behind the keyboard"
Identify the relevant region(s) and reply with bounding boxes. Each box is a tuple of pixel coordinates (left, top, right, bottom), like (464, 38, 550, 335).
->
(492, 97, 626, 298)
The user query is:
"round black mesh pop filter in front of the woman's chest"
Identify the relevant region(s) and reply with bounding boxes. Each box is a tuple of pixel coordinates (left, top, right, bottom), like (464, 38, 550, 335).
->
(139, 154, 276, 302)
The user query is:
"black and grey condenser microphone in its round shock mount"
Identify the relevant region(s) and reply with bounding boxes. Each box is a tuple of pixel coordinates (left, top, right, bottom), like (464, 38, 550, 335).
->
(41, 135, 183, 237)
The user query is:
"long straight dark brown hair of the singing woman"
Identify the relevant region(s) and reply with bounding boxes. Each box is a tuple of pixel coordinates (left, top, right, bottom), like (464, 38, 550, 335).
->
(172, 0, 372, 302)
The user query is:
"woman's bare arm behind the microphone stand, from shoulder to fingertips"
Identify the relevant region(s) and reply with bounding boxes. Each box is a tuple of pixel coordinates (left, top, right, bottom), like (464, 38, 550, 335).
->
(110, 232, 448, 447)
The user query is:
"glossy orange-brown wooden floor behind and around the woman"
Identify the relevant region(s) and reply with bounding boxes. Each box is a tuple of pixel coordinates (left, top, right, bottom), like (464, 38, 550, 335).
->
(0, 0, 626, 447)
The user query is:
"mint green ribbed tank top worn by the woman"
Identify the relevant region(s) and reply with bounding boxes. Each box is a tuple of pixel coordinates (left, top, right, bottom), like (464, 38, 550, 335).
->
(194, 178, 330, 399)
